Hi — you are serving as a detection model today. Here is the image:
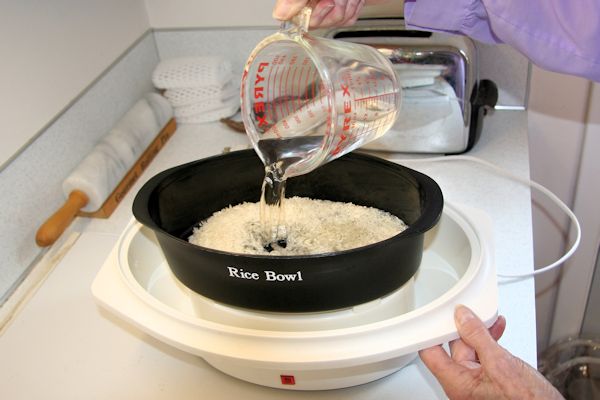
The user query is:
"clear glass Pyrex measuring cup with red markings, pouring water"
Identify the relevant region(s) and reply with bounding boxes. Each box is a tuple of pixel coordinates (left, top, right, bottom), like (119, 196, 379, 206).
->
(241, 7, 401, 179)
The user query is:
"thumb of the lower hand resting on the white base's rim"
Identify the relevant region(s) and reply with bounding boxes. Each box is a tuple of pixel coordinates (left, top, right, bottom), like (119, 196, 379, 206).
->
(454, 305, 504, 362)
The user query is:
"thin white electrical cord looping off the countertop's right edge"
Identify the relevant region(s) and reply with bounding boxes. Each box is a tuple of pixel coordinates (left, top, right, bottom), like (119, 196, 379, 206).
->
(391, 155, 581, 279)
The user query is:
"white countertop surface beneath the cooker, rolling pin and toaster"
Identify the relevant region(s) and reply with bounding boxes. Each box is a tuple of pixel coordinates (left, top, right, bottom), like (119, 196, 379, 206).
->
(0, 111, 536, 399)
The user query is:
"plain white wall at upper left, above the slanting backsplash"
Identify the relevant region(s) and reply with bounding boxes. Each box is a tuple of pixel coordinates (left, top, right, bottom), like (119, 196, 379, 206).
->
(0, 0, 149, 166)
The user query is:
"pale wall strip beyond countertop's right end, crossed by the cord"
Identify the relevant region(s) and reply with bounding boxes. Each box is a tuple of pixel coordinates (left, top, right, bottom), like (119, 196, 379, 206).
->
(528, 66, 590, 351)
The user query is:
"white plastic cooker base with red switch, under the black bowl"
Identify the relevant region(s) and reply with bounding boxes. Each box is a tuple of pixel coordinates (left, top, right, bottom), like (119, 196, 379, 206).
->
(92, 203, 498, 390)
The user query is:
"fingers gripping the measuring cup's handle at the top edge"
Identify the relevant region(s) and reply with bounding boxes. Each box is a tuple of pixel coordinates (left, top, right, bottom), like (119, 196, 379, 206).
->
(273, 0, 389, 28)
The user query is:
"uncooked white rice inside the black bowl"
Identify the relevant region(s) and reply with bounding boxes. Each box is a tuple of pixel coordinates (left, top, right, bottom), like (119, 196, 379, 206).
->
(189, 197, 407, 256)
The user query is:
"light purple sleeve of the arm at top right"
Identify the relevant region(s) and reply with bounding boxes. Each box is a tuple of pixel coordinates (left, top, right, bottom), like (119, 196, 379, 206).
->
(404, 0, 600, 82)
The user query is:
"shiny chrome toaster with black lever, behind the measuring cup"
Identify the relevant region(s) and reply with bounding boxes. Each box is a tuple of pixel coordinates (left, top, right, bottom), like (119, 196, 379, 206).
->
(321, 19, 498, 154)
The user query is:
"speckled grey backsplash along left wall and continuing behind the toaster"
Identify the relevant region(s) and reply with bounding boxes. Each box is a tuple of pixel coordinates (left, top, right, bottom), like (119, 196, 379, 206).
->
(0, 28, 529, 304)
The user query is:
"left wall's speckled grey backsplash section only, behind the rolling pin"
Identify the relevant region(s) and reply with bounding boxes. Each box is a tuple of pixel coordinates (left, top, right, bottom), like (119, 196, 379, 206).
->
(0, 32, 158, 303)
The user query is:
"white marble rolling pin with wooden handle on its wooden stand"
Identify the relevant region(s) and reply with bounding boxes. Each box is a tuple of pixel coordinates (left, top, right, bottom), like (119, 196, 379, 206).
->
(35, 93, 176, 247)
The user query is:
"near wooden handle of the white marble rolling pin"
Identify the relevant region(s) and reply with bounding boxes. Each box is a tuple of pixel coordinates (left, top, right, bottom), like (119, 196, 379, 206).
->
(35, 190, 89, 247)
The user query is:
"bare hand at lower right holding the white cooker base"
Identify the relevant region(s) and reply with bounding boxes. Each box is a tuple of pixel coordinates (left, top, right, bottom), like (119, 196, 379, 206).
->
(419, 306, 563, 400)
